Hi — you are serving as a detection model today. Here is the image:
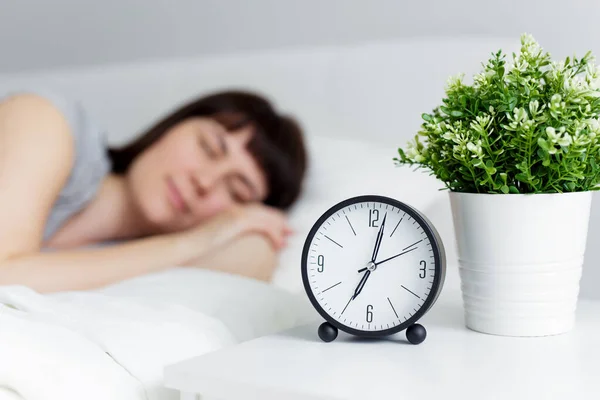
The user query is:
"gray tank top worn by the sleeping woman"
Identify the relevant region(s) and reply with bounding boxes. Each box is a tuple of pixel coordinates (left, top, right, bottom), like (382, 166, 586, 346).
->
(1, 88, 111, 240)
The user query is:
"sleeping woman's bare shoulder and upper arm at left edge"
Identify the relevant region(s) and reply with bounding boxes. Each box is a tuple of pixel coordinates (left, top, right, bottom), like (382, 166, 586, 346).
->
(0, 94, 74, 260)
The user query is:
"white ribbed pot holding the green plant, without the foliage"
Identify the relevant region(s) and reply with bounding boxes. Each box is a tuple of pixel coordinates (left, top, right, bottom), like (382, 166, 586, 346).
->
(450, 192, 593, 336)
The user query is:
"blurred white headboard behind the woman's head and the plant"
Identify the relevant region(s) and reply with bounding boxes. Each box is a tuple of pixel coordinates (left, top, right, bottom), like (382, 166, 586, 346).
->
(0, 37, 518, 145)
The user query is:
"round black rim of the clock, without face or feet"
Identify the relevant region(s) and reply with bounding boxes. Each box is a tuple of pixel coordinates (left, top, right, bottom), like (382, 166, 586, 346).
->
(301, 195, 446, 337)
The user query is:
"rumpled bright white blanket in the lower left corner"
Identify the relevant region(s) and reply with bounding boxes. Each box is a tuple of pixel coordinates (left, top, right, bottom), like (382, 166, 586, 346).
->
(0, 287, 234, 400)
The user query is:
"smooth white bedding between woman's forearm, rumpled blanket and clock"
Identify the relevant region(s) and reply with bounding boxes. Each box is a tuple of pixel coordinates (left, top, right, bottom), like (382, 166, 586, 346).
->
(97, 267, 318, 341)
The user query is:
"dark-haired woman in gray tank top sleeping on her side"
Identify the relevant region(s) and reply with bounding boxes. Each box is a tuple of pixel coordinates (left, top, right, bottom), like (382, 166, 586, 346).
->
(0, 91, 306, 292)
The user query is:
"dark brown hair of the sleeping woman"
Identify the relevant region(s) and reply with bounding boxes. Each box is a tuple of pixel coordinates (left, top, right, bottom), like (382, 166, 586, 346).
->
(109, 91, 307, 209)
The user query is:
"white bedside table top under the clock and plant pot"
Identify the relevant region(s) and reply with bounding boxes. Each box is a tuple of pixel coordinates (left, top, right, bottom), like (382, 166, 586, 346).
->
(165, 293, 600, 400)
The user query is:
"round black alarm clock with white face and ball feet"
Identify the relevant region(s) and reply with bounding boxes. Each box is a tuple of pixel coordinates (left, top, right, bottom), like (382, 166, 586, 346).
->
(302, 195, 446, 344)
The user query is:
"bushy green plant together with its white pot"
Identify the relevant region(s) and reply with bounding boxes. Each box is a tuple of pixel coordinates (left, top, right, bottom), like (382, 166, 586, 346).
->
(394, 34, 600, 336)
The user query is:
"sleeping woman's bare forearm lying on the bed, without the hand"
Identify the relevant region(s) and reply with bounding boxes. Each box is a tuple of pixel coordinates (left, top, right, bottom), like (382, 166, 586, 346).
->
(0, 225, 219, 292)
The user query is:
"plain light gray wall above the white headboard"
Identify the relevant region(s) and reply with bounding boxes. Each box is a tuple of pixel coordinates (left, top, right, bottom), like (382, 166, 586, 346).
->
(0, 0, 600, 72)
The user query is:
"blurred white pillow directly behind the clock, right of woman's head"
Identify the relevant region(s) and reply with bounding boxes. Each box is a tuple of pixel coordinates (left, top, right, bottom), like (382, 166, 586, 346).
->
(273, 136, 449, 293)
